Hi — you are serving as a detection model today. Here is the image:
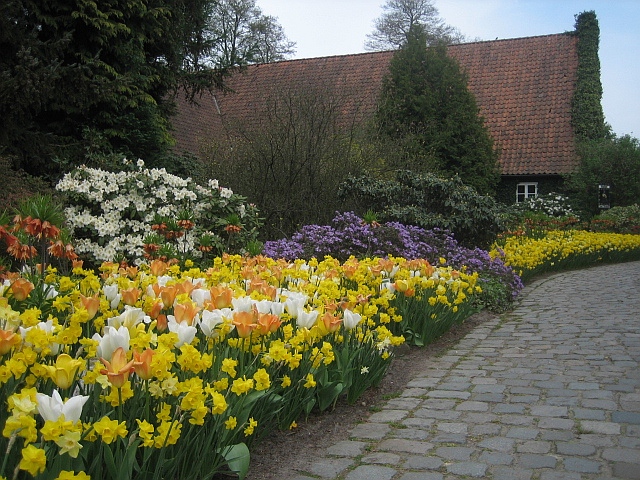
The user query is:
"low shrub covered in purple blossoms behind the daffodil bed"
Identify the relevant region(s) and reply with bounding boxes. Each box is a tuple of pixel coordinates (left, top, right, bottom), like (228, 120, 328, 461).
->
(263, 212, 523, 298)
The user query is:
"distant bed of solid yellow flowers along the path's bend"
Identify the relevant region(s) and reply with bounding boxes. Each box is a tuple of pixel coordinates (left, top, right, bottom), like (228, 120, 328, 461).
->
(491, 230, 640, 280)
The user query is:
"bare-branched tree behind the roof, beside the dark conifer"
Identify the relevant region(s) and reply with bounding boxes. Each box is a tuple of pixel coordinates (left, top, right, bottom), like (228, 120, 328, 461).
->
(206, 0, 295, 68)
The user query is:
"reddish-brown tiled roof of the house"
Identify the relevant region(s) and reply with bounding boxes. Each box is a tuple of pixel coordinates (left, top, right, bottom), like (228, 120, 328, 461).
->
(173, 34, 578, 175)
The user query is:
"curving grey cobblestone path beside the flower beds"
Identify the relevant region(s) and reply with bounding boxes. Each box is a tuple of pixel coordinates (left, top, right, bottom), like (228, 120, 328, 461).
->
(291, 262, 640, 480)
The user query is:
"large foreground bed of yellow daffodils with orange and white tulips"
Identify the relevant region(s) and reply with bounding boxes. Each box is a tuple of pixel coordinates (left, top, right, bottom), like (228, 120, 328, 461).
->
(0, 255, 479, 480)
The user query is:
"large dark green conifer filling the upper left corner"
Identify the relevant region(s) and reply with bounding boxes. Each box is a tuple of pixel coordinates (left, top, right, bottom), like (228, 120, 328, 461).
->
(0, 0, 229, 176)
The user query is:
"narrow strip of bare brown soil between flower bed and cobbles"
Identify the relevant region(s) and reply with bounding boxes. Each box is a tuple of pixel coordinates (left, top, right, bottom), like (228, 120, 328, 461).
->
(246, 311, 495, 480)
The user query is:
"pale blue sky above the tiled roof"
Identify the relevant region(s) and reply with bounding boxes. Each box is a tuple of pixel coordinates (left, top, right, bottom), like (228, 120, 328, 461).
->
(256, 0, 640, 138)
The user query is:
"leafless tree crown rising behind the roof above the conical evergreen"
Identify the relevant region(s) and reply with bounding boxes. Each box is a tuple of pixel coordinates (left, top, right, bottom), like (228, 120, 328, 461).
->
(365, 0, 464, 51)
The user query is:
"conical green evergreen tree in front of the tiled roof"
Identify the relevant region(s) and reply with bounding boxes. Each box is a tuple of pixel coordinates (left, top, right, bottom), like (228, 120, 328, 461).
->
(376, 26, 500, 194)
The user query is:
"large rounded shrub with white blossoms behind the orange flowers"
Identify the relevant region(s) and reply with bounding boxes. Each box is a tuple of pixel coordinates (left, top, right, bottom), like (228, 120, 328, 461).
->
(56, 160, 260, 264)
